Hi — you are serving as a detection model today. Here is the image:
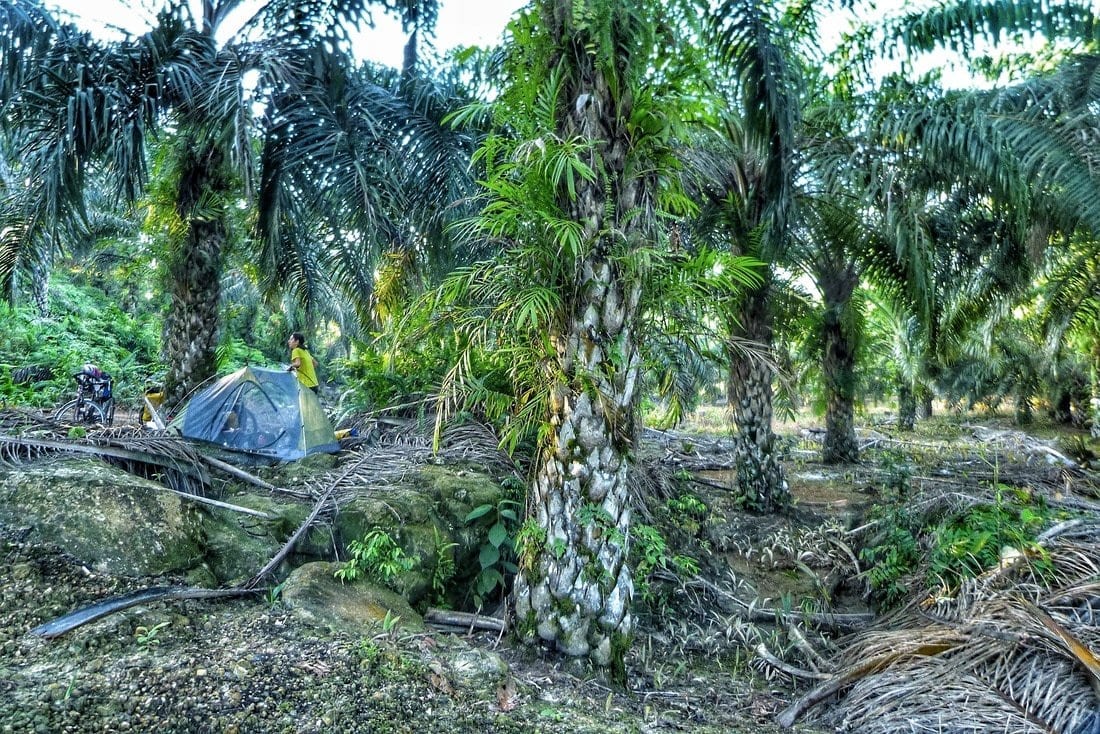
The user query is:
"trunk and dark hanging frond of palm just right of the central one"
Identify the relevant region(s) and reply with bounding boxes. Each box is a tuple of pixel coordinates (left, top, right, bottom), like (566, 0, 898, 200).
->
(711, 0, 801, 512)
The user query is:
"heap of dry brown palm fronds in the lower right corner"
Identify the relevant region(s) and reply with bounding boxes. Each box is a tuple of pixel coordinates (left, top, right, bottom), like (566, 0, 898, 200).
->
(779, 519, 1100, 734)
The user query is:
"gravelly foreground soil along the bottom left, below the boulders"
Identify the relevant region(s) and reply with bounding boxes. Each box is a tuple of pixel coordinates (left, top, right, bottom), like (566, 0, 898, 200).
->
(0, 517, 827, 734)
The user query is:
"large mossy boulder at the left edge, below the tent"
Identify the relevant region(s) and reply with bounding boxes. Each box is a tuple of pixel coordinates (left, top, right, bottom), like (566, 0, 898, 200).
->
(0, 459, 206, 576)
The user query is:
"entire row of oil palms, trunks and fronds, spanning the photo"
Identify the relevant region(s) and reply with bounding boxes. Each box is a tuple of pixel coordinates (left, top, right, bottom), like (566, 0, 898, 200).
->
(0, 0, 1100, 665)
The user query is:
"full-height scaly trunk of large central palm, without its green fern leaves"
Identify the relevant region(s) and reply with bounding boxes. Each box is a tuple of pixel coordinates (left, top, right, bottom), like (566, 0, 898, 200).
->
(515, 0, 655, 676)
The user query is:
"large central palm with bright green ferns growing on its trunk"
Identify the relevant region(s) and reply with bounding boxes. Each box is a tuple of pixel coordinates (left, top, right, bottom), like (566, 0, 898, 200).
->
(422, 0, 765, 668)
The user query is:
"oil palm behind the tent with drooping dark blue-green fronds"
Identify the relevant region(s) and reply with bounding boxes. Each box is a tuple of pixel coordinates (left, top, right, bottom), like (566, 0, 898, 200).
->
(0, 0, 451, 403)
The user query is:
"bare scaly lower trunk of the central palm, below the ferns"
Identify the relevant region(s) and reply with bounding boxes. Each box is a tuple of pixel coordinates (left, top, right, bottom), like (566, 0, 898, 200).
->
(515, 271, 640, 666)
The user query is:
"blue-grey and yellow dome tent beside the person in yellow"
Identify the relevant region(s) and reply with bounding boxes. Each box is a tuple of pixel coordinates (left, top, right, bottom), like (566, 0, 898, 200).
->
(169, 366, 340, 461)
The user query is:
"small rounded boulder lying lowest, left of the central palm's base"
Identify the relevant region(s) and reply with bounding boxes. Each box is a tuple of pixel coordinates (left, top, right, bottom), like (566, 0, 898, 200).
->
(282, 561, 425, 635)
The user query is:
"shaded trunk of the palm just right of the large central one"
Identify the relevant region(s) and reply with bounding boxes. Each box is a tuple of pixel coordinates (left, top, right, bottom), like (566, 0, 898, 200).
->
(726, 285, 791, 512)
